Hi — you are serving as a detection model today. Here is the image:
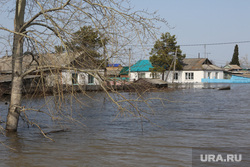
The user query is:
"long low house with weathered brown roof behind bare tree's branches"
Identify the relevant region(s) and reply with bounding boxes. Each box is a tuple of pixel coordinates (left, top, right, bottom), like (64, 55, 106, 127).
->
(0, 53, 104, 87)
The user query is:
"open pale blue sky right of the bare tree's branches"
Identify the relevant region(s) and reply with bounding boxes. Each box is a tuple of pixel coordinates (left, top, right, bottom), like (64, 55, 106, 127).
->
(131, 0, 250, 66)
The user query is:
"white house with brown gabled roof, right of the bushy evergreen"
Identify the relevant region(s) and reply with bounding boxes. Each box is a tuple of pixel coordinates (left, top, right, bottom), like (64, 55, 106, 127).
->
(165, 58, 224, 83)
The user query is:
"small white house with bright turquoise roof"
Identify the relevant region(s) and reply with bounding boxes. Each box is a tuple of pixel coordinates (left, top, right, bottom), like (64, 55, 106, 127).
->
(129, 60, 160, 81)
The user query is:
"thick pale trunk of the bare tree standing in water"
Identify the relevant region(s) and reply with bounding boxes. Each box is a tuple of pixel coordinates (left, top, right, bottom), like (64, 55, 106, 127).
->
(6, 0, 26, 131)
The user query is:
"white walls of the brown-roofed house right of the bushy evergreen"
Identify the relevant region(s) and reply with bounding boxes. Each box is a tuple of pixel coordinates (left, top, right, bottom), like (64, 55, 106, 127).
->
(164, 71, 224, 83)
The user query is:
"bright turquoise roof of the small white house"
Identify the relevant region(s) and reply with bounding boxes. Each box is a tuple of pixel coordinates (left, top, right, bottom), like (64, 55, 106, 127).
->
(130, 60, 154, 72)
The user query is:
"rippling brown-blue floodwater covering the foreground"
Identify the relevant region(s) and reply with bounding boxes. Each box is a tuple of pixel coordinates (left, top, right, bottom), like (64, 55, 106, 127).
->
(0, 84, 250, 167)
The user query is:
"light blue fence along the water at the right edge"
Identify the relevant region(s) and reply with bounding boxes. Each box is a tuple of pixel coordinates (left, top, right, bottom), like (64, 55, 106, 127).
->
(201, 75, 250, 83)
